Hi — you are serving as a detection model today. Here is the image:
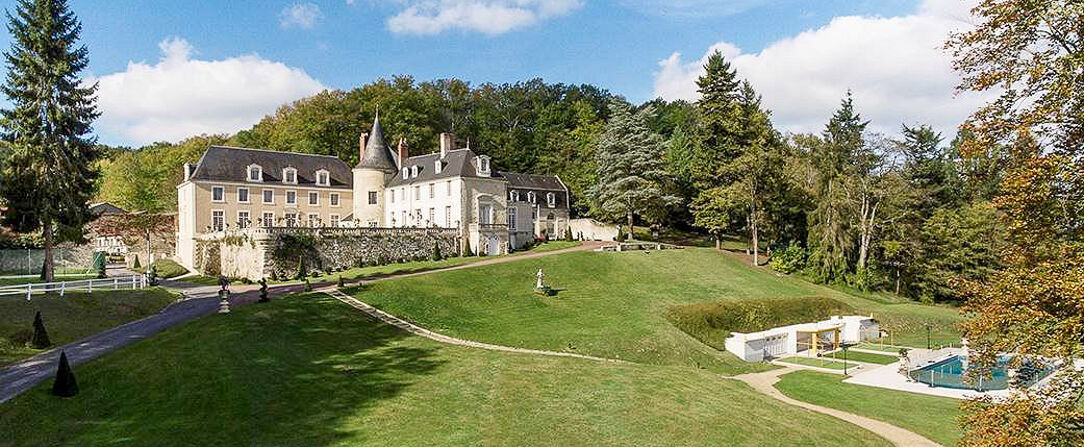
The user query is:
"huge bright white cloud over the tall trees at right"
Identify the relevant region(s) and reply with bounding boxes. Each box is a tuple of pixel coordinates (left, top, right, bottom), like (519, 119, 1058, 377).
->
(655, 0, 989, 137)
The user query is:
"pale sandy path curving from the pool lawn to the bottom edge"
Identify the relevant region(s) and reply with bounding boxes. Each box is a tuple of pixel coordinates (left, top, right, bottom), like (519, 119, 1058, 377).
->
(734, 368, 940, 447)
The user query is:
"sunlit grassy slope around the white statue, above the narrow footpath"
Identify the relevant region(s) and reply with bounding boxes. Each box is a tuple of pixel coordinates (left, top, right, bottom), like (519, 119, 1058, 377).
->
(357, 248, 958, 373)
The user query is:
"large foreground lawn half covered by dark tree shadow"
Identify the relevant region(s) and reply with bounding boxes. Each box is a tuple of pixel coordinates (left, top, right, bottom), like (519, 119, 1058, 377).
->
(0, 295, 887, 446)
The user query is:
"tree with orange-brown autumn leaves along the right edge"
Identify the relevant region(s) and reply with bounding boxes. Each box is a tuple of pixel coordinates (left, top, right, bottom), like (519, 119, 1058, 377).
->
(947, 0, 1084, 446)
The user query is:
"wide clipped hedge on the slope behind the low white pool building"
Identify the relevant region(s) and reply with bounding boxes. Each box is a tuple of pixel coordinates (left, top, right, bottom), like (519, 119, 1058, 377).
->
(667, 297, 854, 350)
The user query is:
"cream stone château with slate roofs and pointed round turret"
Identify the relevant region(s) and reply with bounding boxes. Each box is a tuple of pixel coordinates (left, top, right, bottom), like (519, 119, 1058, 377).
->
(177, 116, 569, 268)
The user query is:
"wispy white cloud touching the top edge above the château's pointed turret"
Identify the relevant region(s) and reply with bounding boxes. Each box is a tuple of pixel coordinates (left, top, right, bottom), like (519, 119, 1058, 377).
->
(387, 0, 583, 35)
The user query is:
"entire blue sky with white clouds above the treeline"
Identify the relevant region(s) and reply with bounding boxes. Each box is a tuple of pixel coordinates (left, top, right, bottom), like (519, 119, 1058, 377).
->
(0, 0, 982, 145)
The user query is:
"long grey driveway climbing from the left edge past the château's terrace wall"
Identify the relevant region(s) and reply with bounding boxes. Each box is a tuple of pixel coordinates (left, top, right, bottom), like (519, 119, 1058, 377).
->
(0, 242, 601, 404)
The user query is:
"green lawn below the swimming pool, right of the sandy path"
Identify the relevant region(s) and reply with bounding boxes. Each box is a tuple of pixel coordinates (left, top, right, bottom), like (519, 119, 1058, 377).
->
(775, 371, 960, 446)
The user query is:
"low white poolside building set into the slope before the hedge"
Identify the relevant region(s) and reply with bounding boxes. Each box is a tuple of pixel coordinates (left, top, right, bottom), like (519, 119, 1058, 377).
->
(725, 316, 880, 361)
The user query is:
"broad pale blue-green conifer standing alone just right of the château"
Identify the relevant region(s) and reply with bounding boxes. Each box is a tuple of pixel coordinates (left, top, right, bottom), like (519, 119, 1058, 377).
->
(591, 100, 681, 239)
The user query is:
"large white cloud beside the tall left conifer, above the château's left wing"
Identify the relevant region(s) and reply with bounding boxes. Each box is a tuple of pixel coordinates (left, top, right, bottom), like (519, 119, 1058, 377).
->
(88, 37, 324, 145)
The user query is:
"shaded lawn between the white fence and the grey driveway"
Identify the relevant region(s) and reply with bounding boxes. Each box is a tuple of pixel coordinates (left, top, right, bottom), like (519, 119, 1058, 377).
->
(0, 288, 177, 366)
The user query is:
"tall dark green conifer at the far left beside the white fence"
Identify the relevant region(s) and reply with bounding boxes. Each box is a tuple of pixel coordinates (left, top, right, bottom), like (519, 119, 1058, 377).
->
(0, 0, 99, 281)
